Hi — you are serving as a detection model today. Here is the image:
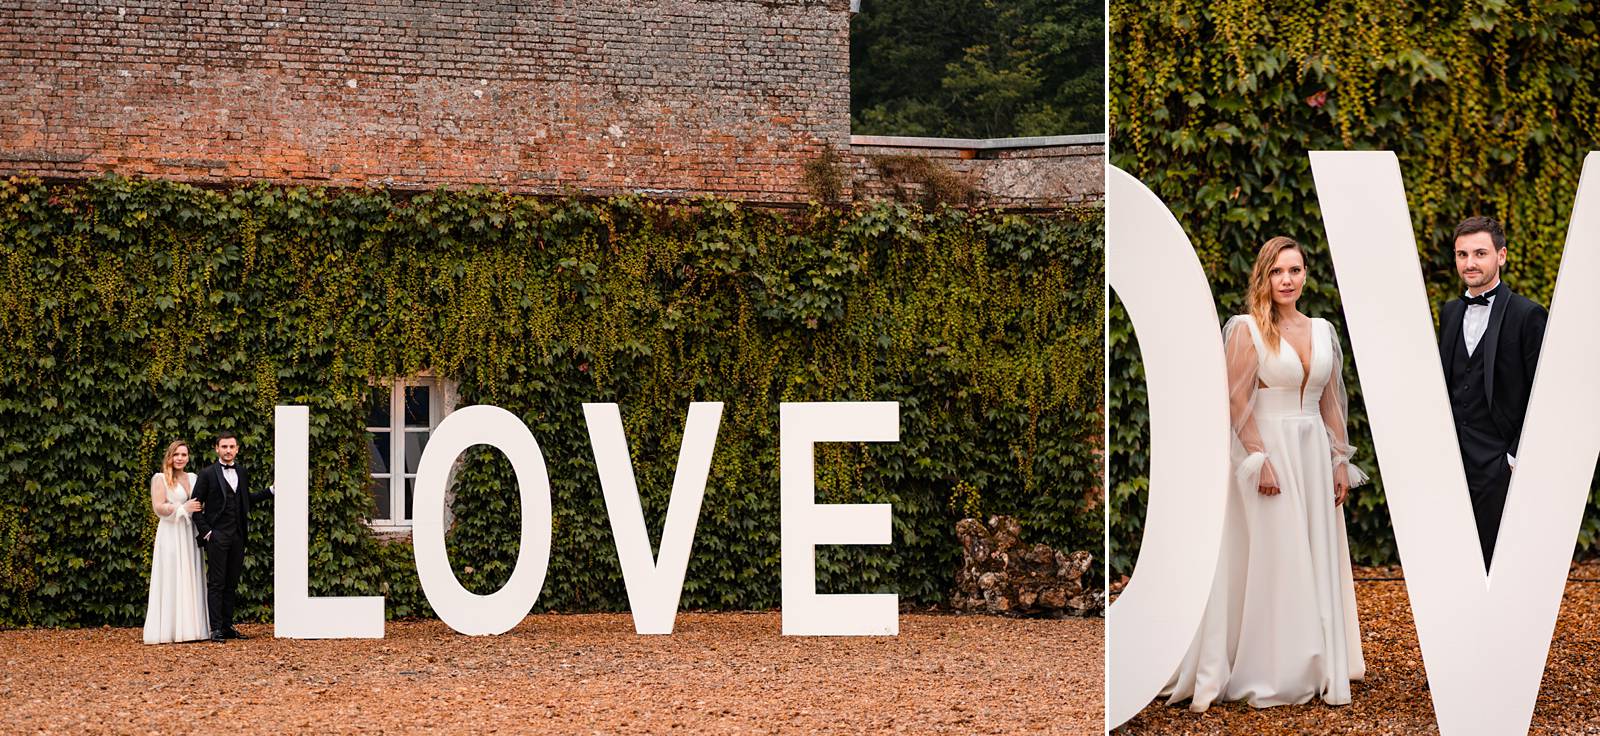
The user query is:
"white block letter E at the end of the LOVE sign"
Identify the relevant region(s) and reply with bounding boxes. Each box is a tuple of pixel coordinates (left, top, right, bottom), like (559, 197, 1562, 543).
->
(778, 402, 899, 637)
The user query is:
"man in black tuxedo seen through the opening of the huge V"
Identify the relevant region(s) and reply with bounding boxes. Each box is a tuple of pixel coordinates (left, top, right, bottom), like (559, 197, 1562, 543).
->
(1438, 216, 1546, 571)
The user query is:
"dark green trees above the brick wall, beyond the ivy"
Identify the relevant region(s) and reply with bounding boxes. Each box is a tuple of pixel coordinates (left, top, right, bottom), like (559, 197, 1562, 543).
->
(850, 0, 1106, 138)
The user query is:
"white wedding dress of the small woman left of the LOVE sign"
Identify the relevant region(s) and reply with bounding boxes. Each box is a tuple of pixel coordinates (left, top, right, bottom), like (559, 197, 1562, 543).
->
(144, 474, 211, 643)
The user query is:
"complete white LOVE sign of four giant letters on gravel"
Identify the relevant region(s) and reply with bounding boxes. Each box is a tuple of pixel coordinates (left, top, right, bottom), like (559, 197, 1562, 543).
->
(272, 402, 899, 638)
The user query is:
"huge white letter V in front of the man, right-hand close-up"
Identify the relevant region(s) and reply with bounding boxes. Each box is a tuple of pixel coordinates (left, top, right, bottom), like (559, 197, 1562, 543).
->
(1310, 150, 1600, 734)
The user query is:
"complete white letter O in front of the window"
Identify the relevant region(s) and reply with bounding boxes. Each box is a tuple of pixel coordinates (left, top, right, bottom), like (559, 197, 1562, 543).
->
(411, 405, 550, 635)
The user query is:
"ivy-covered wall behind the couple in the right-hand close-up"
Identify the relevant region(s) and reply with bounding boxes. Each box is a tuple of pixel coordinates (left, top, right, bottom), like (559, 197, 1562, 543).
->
(1107, 0, 1600, 574)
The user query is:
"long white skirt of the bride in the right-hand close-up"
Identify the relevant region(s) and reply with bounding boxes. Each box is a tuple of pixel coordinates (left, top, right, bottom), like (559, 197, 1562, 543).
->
(1162, 400, 1366, 712)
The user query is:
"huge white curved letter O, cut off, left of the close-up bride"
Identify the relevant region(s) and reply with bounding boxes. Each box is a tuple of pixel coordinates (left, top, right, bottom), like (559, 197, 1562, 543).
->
(1106, 166, 1230, 726)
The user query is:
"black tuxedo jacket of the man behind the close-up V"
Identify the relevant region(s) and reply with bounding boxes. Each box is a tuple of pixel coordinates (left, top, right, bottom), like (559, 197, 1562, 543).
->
(1438, 282, 1547, 456)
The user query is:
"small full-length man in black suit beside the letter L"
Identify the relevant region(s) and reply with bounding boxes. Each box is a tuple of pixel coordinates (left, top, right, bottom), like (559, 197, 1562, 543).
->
(194, 432, 272, 642)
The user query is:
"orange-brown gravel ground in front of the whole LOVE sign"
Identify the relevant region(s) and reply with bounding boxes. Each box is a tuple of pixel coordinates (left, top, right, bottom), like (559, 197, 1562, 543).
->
(0, 613, 1104, 734)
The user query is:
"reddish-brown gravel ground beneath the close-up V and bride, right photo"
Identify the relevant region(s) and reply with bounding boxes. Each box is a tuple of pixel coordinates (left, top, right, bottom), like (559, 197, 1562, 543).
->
(1115, 563, 1600, 736)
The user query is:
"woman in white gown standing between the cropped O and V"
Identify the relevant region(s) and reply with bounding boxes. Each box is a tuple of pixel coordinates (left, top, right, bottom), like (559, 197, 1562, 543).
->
(1163, 237, 1366, 712)
